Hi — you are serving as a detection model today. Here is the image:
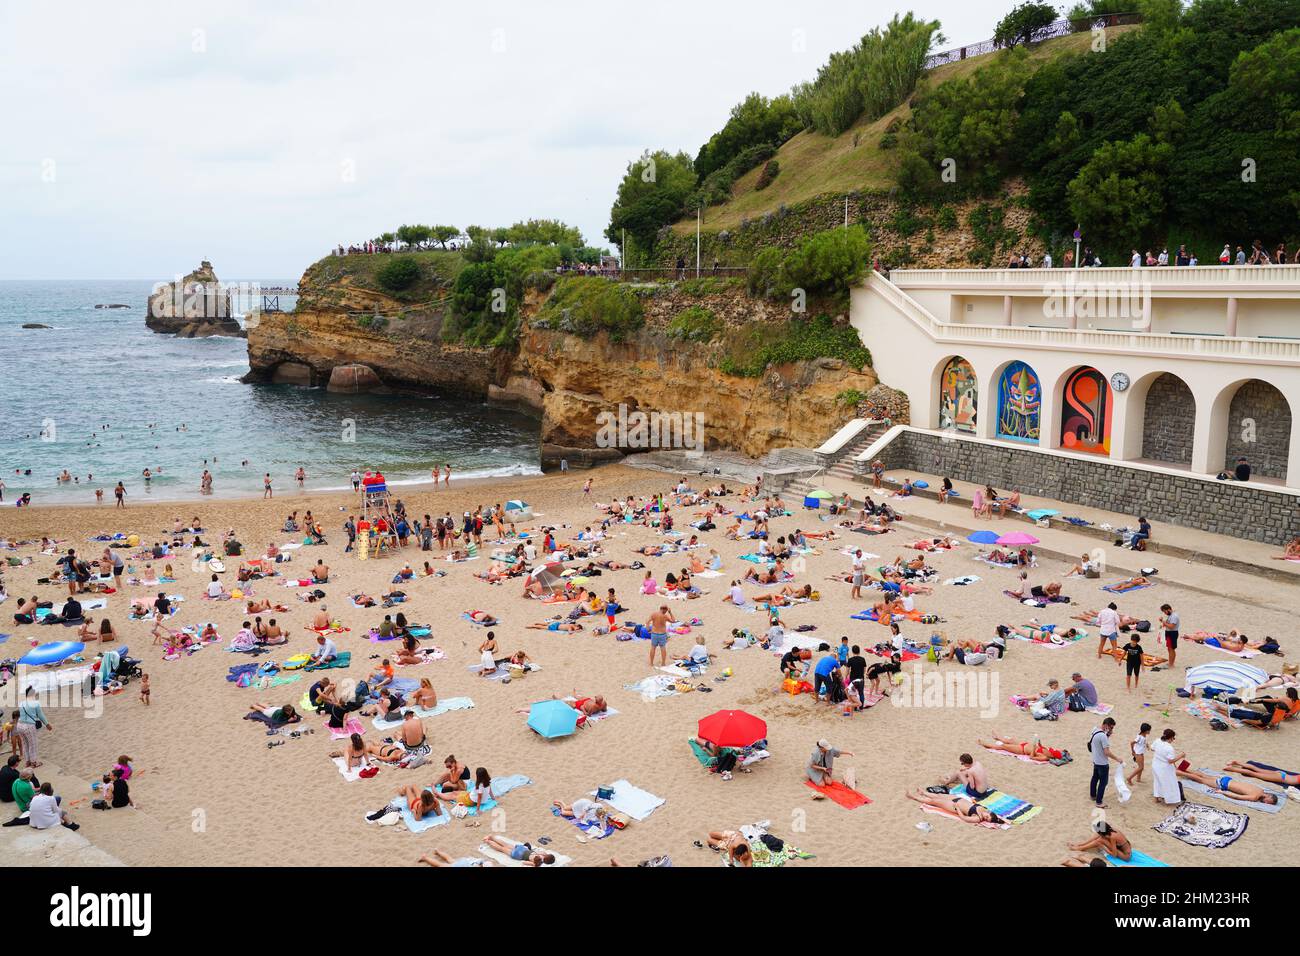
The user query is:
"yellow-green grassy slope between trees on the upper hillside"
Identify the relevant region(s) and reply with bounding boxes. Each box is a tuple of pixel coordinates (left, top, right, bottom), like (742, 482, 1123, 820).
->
(673, 26, 1136, 233)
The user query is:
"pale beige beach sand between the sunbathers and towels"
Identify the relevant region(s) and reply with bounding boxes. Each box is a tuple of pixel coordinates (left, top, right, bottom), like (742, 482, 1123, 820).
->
(0, 466, 1300, 866)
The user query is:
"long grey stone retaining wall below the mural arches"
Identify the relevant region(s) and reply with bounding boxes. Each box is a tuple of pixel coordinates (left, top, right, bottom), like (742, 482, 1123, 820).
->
(878, 429, 1300, 545)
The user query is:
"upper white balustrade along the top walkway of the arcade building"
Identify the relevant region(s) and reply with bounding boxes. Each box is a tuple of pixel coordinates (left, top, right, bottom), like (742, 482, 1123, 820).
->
(889, 264, 1300, 293)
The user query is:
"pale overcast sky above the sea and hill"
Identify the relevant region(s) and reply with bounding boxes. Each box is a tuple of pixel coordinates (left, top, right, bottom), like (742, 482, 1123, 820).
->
(0, 0, 993, 281)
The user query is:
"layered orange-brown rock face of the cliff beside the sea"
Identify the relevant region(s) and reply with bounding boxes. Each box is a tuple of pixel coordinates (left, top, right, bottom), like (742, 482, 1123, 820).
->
(247, 256, 894, 466)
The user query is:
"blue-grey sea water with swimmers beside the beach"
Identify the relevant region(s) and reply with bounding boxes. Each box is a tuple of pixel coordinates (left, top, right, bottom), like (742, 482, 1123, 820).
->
(0, 281, 540, 504)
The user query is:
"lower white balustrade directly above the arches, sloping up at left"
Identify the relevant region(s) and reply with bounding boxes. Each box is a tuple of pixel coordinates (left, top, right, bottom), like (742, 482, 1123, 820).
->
(867, 278, 1300, 364)
